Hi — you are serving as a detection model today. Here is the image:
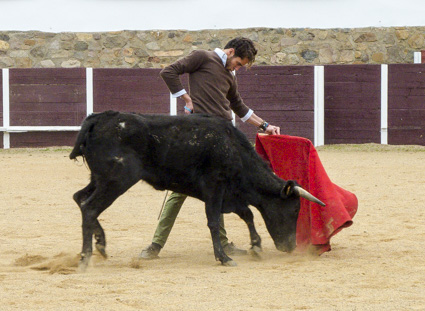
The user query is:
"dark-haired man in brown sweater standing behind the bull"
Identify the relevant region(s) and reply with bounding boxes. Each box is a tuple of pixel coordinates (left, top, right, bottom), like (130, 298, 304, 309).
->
(140, 37, 280, 259)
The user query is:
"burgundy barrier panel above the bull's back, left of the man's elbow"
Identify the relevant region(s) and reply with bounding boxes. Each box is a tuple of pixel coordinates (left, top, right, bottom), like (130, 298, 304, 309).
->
(93, 69, 170, 114)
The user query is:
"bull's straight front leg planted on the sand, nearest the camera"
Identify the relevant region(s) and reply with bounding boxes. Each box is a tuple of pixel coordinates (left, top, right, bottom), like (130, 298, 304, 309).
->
(205, 186, 236, 266)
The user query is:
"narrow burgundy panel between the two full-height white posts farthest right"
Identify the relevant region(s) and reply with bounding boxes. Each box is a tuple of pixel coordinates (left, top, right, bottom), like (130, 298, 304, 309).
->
(325, 65, 381, 144)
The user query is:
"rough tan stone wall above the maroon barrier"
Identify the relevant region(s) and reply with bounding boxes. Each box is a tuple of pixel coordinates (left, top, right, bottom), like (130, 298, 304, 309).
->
(0, 27, 425, 68)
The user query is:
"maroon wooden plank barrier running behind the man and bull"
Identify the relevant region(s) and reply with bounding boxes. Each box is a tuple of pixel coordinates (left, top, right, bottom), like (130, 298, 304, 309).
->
(0, 64, 425, 147)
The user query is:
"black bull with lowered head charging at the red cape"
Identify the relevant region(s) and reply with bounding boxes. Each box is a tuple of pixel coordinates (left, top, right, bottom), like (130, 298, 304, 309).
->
(70, 111, 323, 269)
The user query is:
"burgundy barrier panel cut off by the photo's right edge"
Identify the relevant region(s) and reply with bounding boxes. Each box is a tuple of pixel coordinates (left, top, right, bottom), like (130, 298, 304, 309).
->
(388, 64, 425, 145)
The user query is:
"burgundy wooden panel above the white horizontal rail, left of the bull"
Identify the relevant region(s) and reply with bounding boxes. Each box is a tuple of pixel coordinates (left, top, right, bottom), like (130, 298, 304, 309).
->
(9, 68, 86, 126)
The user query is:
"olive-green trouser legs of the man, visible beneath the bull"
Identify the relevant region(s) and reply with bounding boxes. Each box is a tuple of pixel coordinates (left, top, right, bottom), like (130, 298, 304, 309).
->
(152, 192, 229, 247)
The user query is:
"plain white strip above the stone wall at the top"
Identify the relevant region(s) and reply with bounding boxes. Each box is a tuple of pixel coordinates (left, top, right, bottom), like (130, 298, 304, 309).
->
(0, 0, 425, 32)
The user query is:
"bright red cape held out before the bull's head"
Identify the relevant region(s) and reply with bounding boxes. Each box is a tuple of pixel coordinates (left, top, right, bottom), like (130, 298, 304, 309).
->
(255, 135, 358, 255)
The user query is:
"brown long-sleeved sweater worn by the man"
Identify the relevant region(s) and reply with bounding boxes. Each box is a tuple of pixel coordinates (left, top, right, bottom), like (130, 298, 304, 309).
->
(160, 50, 249, 120)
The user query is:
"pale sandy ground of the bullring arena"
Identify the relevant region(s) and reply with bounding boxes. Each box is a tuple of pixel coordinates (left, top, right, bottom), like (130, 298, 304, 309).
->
(0, 145, 425, 311)
